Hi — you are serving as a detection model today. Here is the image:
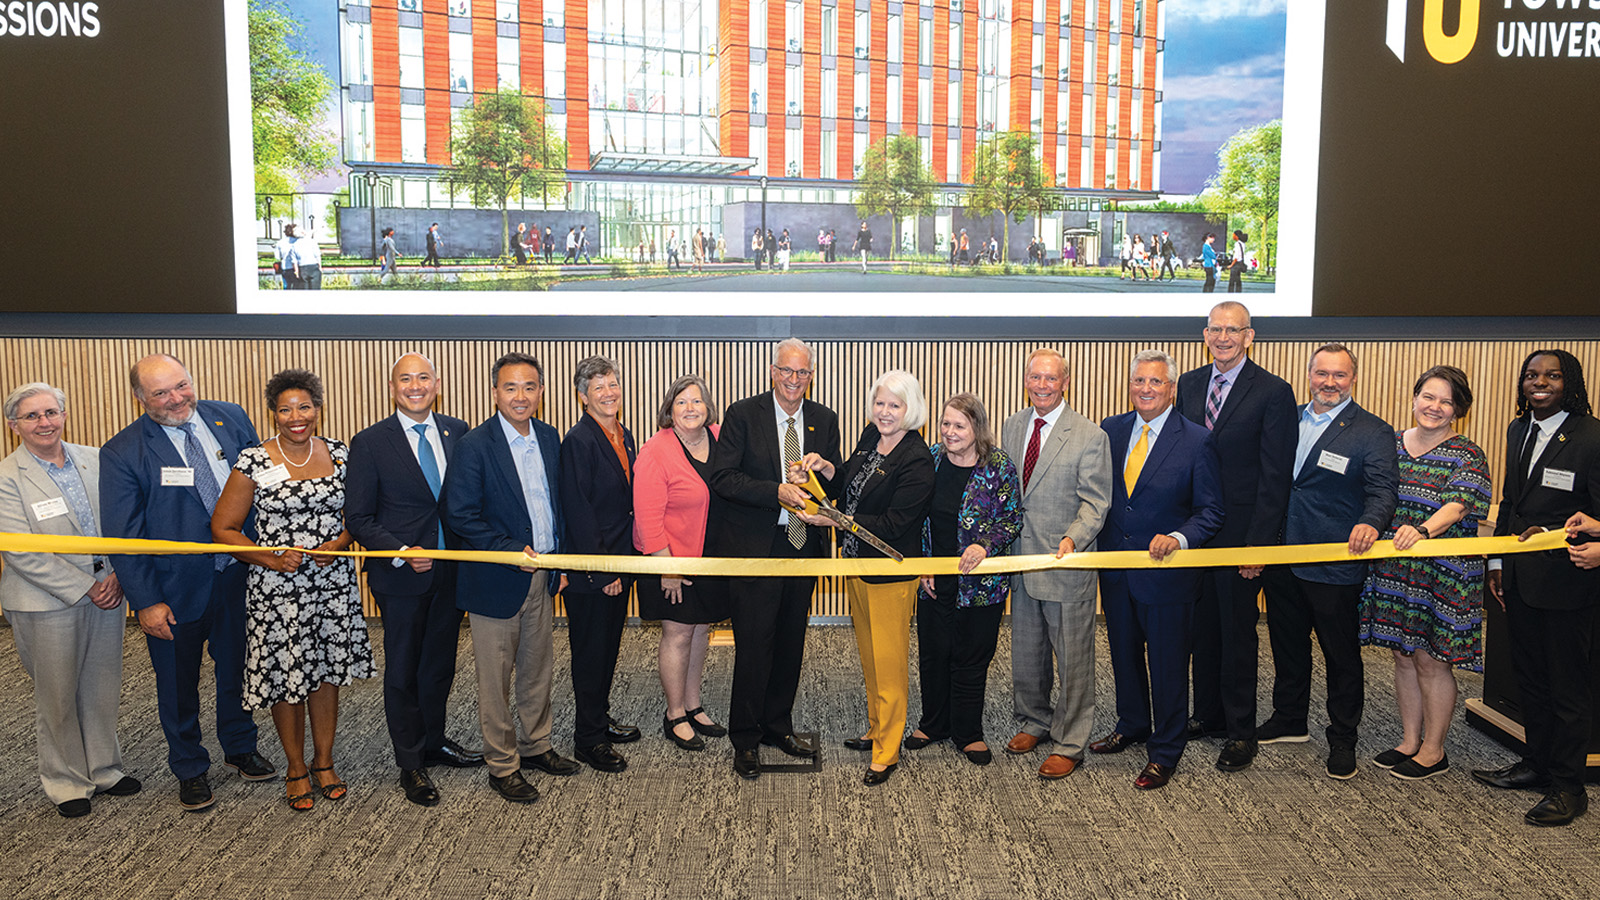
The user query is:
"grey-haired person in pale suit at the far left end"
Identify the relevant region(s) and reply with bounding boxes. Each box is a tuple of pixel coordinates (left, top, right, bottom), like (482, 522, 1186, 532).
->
(0, 381, 142, 818)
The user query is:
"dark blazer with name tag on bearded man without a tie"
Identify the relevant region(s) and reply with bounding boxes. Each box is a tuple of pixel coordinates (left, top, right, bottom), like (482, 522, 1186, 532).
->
(1280, 400, 1400, 585)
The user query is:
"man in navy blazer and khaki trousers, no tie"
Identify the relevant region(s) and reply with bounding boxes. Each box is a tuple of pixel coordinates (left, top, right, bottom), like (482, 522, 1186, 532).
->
(440, 352, 579, 802)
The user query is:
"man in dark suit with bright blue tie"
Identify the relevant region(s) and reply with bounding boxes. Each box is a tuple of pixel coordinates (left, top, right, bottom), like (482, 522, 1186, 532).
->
(344, 352, 483, 806)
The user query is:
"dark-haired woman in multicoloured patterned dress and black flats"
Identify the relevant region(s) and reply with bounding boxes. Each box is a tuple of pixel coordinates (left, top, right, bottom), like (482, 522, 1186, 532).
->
(1362, 365, 1490, 780)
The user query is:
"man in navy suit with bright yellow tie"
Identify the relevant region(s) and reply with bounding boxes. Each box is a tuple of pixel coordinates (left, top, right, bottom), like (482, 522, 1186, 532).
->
(1090, 351, 1222, 791)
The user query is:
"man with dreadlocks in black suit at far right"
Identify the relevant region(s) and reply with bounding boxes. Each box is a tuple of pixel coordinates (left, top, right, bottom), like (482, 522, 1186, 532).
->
(1472, 349, 1600, 825)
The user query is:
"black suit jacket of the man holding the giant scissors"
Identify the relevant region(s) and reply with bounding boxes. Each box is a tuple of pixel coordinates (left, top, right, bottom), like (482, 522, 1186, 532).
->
(706, 391, 844, 557)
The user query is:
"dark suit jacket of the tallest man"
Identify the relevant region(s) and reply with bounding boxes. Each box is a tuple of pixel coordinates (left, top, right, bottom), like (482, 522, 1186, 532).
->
(1178, 359, 1299, 546)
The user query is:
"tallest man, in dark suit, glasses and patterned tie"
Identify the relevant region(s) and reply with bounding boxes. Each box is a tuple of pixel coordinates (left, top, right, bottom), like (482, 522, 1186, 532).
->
(1178, 299, 1294, 772)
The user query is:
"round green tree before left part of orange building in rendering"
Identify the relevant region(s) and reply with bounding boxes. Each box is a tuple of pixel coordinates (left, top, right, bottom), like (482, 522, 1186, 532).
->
(445, 90, 566, 255)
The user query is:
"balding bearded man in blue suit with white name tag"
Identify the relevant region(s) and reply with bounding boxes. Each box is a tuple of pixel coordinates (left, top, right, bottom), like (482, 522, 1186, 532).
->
(101, 354, 277, 810)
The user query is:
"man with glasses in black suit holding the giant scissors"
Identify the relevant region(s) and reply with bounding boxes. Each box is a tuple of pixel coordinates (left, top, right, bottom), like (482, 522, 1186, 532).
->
(706, 338, 842, 778)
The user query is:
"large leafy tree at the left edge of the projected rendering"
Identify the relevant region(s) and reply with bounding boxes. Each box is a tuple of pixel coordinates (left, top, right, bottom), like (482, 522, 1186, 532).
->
(248, 0, 338, 215)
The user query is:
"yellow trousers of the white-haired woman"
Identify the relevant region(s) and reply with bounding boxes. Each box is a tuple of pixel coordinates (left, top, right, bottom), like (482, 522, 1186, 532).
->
(845, 578, 917, 765)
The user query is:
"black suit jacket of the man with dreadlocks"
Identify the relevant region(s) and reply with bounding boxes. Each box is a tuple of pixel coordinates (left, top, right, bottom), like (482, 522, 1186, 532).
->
(1494, 413, 1600, 610)
